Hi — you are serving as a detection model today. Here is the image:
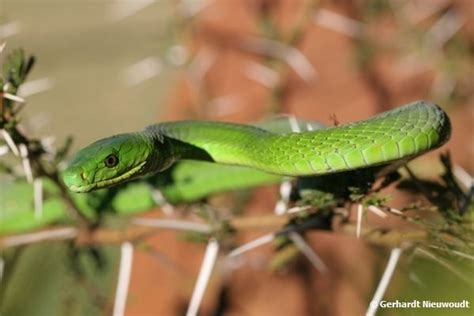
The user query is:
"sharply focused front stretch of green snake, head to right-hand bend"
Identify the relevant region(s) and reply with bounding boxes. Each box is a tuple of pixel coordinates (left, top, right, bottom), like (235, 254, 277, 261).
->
(63, 101, 451, 192)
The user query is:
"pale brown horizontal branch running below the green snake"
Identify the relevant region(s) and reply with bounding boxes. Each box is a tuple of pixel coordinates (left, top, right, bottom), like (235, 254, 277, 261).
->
(0, 214, 428, 249)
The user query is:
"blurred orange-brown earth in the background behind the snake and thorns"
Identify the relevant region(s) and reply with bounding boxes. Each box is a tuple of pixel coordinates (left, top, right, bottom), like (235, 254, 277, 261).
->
(126, 1, 474, 316)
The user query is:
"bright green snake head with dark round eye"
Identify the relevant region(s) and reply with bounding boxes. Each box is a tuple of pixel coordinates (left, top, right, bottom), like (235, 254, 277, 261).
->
(62, 133, 153, 193)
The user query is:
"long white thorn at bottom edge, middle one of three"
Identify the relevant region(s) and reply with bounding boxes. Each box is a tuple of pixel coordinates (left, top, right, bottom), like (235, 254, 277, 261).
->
(186, 239, 219, 316)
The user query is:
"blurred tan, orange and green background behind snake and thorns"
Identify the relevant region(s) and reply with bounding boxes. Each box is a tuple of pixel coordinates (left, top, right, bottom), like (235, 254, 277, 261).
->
(0, 0, 474, 316)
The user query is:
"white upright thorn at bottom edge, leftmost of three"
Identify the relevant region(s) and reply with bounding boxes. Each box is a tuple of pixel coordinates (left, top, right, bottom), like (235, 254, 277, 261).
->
(113, 241, 133, 316)
